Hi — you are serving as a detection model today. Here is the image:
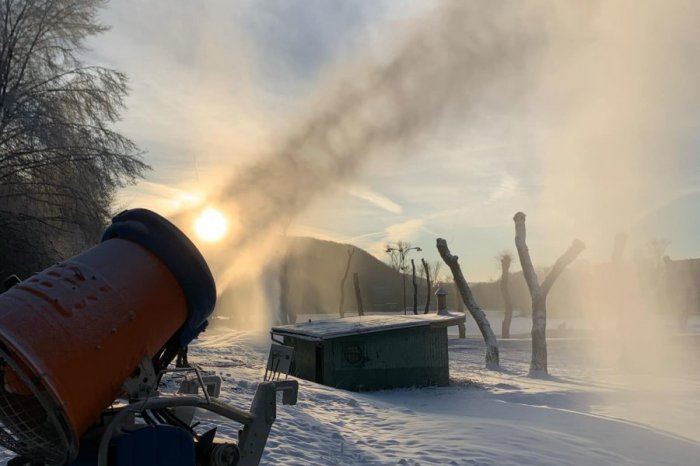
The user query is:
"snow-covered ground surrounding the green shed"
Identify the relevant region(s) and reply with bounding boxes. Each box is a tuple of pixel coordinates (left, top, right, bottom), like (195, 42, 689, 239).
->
(0, 313, 700, 465)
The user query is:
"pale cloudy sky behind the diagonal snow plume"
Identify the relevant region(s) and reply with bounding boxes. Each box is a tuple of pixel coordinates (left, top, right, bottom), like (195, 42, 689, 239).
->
(87, 0, 700, 281)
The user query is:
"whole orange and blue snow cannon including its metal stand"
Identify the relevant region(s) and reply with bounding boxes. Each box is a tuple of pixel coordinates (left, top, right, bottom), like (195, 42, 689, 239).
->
(0, 209, 298, 466)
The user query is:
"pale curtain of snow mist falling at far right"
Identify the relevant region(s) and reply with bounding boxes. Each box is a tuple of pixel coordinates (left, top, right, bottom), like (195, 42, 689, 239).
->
(528, 0, 700, 436)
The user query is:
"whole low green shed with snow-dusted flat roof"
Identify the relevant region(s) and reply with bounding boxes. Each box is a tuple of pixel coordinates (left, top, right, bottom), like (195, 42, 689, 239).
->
(271, 314, 464, 391)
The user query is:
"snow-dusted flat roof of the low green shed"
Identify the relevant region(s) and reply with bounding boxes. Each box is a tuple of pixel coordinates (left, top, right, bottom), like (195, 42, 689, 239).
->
(272, 313, 464, 340)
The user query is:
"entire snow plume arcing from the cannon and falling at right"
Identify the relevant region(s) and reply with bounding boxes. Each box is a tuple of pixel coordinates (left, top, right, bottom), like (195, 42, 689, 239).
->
(179, 0, 700, 404)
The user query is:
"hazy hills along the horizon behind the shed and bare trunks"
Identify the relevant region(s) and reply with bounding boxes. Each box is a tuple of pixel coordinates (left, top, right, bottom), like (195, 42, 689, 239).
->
(220, 237, 700, 328)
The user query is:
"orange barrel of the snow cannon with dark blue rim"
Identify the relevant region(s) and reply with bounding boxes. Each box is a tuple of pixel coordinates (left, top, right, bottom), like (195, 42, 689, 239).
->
(0, 209, 216, 464)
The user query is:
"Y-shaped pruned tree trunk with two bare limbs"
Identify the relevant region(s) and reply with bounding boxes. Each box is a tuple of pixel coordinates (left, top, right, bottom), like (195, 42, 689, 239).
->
(513, 212, 586, 375)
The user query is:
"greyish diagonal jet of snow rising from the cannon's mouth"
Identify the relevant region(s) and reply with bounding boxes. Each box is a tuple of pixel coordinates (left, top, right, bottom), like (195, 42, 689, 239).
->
(185, 1, 545, 323)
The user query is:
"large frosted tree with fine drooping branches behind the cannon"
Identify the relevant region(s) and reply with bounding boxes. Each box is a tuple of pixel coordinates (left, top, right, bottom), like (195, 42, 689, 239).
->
(0, 0, 148, 274)
